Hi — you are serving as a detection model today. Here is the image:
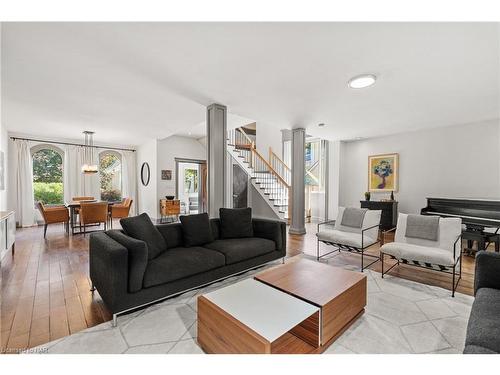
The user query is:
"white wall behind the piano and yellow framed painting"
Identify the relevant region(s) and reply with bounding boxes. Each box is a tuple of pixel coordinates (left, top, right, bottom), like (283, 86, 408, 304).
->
(339, 120, 500, 213)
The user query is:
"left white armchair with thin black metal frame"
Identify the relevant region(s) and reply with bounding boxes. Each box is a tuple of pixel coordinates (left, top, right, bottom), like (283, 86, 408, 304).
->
(316, 207, 382, 272)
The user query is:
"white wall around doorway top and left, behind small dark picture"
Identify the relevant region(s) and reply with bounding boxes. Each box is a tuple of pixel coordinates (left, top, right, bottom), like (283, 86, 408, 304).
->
(157, 135, 207, 199)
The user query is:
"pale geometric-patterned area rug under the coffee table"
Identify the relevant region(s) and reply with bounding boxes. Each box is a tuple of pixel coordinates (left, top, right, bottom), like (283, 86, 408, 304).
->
(30, 254, 473, 354)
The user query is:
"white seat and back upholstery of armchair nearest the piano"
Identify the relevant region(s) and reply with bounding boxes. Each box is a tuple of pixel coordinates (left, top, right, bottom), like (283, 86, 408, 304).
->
(394, 213, 462, 252)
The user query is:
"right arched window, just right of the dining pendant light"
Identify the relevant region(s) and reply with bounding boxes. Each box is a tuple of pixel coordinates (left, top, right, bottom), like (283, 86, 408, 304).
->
(99, 151, 122, 202)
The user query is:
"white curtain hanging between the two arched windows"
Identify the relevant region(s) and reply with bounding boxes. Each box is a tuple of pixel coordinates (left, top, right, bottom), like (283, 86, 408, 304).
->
(63, 146, 101, 202)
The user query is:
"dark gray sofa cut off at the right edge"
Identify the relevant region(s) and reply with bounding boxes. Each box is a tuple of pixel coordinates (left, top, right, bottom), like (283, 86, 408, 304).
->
(464, 251, 500, 354)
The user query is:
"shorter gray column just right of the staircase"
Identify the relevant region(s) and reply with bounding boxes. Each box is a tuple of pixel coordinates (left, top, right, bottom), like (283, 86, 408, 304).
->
(289, 128, 306, 234)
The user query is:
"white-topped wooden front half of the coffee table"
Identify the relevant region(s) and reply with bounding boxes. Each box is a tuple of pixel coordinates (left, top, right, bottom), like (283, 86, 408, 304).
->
(197, 279, 320, 354)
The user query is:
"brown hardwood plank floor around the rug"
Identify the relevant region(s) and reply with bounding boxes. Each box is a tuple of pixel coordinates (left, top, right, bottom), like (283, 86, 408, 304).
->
(0, 222, 480, 352)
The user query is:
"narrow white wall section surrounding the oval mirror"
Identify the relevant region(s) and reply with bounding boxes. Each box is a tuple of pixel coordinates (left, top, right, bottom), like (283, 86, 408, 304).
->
(137, 139, 159, 219)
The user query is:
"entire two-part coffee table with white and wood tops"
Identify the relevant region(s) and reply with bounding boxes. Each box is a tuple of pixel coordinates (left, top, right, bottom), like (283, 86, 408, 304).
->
(197, 259, 366, 354)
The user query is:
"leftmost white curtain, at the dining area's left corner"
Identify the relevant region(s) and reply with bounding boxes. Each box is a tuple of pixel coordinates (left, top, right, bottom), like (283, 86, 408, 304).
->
(14, 139, 35, 227)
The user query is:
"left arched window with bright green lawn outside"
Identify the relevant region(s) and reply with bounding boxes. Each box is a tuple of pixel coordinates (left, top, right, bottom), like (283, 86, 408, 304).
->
(31, 145, 64, 204)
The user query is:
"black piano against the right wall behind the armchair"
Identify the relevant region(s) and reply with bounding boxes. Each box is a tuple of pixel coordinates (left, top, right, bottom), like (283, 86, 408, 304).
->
(420, 198, 500, 252)
